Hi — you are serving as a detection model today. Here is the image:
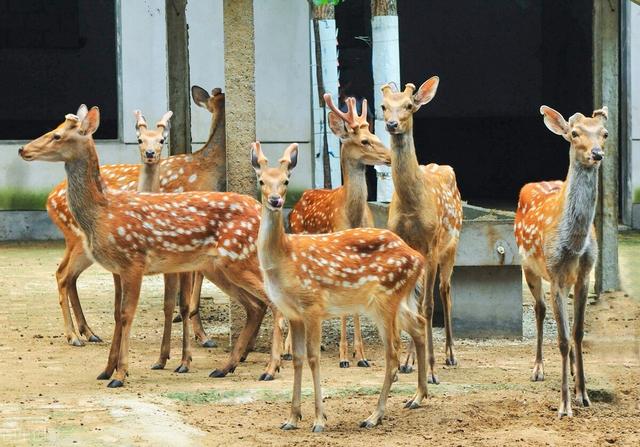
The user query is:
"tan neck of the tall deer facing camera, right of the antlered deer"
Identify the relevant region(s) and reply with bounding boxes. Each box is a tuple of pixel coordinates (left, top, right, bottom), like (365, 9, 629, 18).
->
(391, 132, 423, 205)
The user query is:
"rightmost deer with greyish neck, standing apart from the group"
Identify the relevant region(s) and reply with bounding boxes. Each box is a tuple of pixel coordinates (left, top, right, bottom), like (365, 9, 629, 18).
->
(514, 106, 608, 417)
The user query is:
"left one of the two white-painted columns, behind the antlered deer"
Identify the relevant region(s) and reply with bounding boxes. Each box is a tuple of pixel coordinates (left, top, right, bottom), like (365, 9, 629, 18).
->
(309, 19, 342, 188)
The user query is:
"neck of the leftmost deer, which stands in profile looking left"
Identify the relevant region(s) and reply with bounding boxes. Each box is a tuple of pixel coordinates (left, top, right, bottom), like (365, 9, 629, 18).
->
(64, 139, 107, 239)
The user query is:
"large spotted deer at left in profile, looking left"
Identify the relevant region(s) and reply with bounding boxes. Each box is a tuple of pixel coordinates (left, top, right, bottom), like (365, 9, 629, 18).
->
(19, 105, 282, 388)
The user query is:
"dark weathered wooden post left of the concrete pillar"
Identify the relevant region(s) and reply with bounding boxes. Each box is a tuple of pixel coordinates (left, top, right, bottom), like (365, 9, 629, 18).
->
(165, 0, 191, 155)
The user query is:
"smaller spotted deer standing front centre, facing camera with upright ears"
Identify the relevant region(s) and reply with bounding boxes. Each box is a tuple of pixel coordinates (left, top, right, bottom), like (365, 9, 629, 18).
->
(251, 143, 427, 432)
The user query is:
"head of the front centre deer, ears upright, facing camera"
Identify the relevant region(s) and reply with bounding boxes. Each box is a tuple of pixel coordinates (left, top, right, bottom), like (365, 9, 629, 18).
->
(251, 141, 298, 211)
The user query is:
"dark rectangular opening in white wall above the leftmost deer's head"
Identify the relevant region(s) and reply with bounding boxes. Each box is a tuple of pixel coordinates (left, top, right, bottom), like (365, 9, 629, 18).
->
(0, 0, 118, 140)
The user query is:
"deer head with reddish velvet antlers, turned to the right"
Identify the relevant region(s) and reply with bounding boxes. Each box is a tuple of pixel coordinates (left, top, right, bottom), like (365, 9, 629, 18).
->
(324, 93, 391, 165)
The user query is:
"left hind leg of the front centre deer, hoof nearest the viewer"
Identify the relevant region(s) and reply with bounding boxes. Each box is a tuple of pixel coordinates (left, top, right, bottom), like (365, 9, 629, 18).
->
(360, 311, 400, 428)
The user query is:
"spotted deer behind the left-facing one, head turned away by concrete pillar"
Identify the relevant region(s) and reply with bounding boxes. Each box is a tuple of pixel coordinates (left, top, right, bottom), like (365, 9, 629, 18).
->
(46, 86, 226, 347)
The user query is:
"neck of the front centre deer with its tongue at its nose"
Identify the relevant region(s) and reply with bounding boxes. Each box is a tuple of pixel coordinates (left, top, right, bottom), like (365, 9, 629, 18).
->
(257, 204, 288, 271)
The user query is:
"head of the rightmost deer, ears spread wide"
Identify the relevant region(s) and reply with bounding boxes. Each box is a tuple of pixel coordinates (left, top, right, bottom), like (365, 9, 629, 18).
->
(540, 106, 609, 168)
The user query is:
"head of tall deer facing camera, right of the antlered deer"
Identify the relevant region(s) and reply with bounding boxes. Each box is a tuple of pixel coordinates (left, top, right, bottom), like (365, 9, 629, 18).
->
(380, 76, 440, 134)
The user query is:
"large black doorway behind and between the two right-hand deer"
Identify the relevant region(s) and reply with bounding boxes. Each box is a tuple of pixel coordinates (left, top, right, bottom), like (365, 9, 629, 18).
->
(398, 0, 593, 209)
